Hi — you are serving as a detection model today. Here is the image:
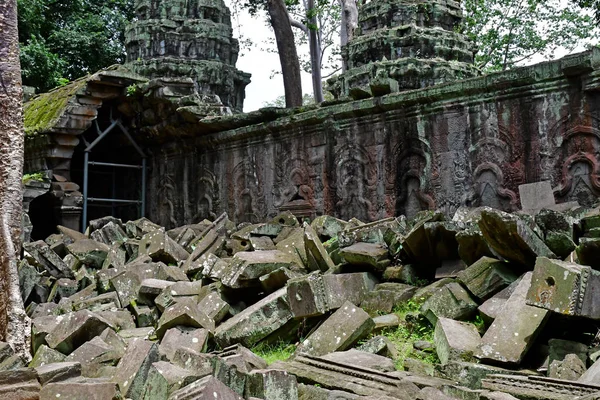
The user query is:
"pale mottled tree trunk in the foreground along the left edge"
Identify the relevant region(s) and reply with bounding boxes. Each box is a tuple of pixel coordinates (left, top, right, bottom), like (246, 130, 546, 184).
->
(0, 0, 30, 359)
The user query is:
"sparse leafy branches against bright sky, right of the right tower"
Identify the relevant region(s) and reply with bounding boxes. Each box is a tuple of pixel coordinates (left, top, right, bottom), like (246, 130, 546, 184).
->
(461, 0, 597, 72)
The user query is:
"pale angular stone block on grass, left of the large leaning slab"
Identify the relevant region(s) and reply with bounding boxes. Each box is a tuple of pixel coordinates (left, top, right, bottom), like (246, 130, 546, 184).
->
(434, 318, 481, 365)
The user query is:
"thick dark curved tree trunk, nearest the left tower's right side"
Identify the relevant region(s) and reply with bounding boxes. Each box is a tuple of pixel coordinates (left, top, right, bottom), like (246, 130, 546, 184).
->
(267, 0, 302, 108)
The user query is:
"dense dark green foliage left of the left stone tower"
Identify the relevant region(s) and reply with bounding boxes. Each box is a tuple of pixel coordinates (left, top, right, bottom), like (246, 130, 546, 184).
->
(18, 0, 133, 92)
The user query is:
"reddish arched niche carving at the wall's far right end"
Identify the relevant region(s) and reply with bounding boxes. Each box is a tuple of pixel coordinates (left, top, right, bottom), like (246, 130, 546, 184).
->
(542, 114, 600, 206)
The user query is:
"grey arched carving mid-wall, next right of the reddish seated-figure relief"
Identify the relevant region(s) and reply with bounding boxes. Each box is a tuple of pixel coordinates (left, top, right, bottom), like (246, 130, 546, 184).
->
(335, 143, 377, 220)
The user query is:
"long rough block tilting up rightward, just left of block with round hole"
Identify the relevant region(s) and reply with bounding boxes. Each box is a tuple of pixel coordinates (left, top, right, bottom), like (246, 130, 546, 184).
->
(214, 288, 293, 347)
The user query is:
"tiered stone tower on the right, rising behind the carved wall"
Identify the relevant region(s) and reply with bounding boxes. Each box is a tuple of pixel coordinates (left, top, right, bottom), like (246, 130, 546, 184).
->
(328, 0, 478, 98)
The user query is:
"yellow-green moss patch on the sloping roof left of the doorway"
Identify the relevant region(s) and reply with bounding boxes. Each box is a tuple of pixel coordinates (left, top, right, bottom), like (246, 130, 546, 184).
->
(23, 77, 89, 137)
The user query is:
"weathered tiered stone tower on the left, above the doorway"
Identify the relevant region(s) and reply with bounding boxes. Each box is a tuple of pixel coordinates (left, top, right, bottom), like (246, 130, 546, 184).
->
(126, 0, 250, 112)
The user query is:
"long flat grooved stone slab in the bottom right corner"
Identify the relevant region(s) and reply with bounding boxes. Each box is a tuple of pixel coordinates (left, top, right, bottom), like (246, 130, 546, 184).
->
(482, 375, 600, 400)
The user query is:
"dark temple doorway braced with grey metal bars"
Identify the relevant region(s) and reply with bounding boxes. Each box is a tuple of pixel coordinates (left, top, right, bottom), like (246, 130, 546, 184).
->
(71, 109, 146, 231)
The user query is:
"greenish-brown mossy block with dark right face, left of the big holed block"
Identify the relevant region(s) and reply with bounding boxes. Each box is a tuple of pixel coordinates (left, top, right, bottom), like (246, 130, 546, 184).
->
(458, 257, 518, 301)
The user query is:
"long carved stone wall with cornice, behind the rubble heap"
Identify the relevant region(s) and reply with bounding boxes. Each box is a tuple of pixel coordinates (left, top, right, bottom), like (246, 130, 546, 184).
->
(144, 49, 600, 226)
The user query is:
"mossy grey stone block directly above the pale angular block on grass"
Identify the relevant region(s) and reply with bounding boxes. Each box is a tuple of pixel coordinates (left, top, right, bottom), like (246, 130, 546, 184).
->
(415, 282, 478, 326)
